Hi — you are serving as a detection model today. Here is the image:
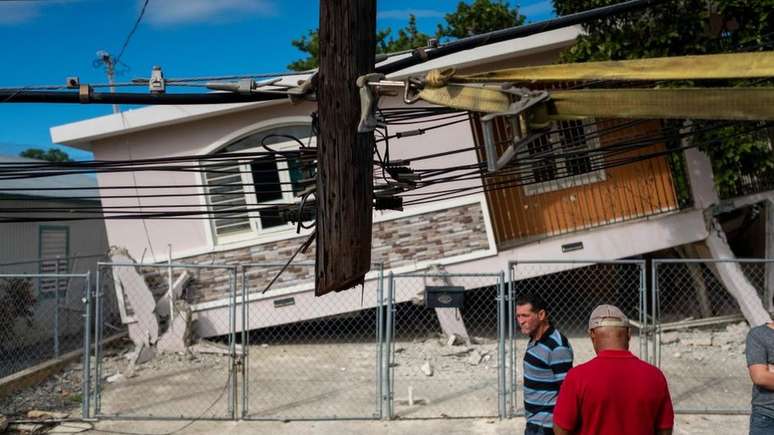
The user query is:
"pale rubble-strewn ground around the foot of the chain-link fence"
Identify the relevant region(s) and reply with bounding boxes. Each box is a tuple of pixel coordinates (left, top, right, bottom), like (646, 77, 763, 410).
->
(0, 316, 751, 435)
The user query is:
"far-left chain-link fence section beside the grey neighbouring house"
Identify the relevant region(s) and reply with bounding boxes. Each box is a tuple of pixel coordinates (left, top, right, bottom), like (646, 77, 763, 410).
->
(0, 273, 90, 384)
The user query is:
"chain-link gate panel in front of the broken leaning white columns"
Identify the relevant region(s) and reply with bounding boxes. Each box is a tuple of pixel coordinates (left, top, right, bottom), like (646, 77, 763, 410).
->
(93, 262, 240, 419)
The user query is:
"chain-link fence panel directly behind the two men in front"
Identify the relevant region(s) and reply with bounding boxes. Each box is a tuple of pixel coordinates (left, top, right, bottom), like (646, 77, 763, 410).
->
(507, 260, 653, 415)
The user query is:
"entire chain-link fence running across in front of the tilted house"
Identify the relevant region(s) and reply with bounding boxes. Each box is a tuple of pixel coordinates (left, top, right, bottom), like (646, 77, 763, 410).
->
(0, 259, 756, 420)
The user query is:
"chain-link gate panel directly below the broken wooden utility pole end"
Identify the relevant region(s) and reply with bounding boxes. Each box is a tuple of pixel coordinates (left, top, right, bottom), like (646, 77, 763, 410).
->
(237, 263, 384, 420)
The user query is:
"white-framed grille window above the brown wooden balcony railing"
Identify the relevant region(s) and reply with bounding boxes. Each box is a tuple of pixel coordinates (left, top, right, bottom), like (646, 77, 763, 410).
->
(523, 119, 605, 195)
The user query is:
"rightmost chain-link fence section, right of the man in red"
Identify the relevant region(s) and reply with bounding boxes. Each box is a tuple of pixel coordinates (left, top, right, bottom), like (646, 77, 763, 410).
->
(653, 260, 774, 412)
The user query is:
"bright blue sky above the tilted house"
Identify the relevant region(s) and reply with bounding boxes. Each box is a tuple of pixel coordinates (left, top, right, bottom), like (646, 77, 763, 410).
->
(0, 0, 553, 160)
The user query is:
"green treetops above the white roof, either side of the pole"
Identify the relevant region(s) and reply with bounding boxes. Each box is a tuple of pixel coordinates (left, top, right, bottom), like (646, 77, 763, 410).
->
(288, 0, 525, 71)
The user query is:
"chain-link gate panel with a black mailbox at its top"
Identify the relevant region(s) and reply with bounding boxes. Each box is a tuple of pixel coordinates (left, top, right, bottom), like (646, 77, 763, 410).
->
(387, 273, 506, 419)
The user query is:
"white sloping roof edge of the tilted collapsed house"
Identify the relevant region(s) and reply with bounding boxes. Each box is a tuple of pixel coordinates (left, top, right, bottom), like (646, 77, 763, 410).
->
(50, 26, 582, 150)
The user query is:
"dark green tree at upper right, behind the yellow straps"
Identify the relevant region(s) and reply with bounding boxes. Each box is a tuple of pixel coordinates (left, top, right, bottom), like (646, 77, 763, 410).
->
(554, 0, 774, 196)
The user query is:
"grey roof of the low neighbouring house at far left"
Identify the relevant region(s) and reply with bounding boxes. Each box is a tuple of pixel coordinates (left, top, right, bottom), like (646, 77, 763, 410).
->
(0, 154, 99, 200)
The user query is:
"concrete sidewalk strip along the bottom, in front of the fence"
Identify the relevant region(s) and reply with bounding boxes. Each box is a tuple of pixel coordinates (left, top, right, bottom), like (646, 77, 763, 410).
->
(90, 415, 749, 435)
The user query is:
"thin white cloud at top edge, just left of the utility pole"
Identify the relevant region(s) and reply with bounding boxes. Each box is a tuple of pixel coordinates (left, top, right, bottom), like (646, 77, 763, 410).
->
(144, 0, 275, 25)
